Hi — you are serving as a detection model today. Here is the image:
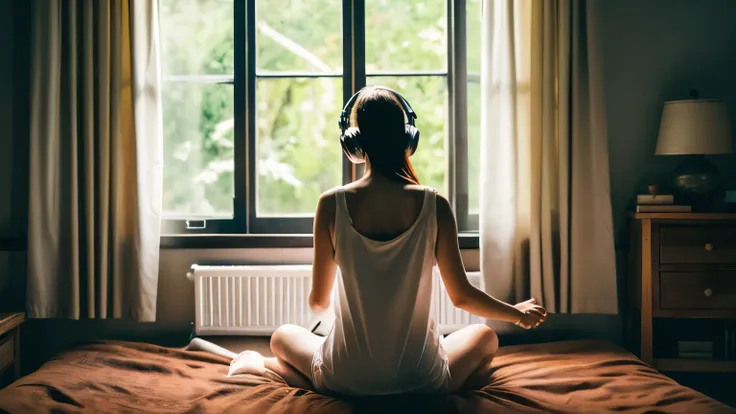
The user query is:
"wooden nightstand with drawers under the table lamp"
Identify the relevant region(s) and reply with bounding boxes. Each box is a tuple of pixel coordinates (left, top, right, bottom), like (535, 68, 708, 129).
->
(624, 213, 736, 372)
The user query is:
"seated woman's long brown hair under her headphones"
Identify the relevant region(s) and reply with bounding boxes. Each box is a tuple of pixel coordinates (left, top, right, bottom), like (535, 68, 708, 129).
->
(350, 87, 419, 184)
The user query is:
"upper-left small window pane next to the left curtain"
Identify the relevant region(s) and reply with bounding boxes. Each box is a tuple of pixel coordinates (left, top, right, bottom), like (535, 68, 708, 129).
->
(159, 0, 235, 78)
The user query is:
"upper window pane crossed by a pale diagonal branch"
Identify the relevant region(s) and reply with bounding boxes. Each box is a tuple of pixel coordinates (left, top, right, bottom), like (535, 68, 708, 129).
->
(256, 0, 342, 74)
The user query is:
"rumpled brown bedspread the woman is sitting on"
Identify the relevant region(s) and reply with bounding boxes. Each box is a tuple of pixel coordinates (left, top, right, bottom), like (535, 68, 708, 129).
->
(0, 341, 736, 414)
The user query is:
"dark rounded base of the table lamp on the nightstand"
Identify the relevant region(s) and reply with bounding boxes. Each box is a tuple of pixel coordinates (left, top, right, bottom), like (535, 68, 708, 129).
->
(673, 155, 721, 211)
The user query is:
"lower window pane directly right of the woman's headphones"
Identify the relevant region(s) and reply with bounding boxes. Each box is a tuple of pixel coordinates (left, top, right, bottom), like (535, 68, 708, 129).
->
(367, 76, 448, 195)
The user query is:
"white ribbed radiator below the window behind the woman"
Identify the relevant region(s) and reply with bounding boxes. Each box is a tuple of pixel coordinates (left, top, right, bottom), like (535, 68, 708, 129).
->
(187, 265, 481, 336)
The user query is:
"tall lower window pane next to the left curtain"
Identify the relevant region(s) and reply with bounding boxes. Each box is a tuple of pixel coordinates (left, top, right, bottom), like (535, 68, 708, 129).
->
(162, 82, 234, 218)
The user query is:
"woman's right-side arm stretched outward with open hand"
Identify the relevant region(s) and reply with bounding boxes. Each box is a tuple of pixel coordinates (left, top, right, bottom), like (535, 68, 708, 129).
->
(435, 196, 543, 328)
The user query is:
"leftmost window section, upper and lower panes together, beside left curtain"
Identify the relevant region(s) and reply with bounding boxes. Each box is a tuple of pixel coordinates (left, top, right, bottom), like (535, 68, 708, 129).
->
(159, 0, 237, 232)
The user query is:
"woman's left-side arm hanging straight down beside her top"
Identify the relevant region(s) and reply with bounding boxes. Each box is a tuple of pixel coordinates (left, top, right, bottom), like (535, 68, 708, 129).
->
(309, 191, 337, 313)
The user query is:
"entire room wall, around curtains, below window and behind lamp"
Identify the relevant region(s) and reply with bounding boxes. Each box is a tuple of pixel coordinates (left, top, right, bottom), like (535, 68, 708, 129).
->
(0, 0, 736, 367)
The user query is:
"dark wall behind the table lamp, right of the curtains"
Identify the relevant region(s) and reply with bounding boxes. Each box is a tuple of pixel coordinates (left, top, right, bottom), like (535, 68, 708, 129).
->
(596, 0, 736, 246)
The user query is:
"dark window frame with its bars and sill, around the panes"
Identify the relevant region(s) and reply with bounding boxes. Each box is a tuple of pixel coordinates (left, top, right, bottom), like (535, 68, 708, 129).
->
(162, 0, 479, 236)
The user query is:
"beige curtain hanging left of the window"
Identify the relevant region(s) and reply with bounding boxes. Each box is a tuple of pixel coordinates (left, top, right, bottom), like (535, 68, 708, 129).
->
(27, 0, 162, 321)
